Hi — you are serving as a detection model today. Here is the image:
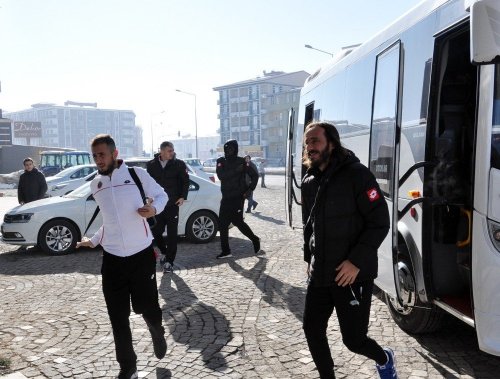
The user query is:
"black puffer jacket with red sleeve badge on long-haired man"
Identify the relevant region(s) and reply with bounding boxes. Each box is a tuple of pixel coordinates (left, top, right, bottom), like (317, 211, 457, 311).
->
(302, 153, 390, 286)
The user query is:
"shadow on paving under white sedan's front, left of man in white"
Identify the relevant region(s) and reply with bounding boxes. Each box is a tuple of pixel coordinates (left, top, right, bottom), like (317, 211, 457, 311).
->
(0, 247, 102, 275)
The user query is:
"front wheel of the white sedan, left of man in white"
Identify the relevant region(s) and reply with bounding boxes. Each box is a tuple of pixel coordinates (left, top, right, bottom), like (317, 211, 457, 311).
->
(38, 219, 78, 255)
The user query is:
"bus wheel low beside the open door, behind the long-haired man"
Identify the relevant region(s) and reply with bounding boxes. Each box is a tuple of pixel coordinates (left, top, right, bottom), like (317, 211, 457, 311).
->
(385, 246, 443, 334)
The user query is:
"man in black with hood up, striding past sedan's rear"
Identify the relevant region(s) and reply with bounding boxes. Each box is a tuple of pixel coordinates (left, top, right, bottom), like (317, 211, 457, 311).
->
(216, 139, 261, 259)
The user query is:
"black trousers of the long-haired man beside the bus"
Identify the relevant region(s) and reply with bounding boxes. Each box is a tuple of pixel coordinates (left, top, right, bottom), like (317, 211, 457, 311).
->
(303, 281, 387, 378)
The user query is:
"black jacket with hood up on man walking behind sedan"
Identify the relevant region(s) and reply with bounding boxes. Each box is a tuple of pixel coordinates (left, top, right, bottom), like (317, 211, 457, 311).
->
(216, 140, 259, 199)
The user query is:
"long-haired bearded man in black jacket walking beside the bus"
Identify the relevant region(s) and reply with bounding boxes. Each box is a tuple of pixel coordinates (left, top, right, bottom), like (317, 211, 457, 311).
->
(301, 122, 397, 378)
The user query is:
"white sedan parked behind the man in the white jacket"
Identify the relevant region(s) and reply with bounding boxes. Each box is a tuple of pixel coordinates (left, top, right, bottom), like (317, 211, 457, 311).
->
(1, 175, 221, 255)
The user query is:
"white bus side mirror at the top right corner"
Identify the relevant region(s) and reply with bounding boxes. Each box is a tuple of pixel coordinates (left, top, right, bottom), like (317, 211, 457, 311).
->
(470, 0, 500, 65)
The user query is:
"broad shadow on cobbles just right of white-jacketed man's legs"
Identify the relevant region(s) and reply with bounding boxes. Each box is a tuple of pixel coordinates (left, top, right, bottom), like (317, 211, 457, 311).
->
(158, 273, 232, 377)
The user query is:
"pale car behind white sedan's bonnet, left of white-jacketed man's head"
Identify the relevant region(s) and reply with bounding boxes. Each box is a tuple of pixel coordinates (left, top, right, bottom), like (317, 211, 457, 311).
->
(45, 164, 97, 196)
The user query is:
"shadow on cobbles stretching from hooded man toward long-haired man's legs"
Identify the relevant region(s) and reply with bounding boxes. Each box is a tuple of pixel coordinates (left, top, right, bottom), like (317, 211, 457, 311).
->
(227, 256, 306, 322)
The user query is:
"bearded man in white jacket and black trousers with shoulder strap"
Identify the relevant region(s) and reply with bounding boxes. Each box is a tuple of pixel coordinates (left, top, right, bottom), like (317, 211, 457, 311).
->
(76, 134, 168, 379)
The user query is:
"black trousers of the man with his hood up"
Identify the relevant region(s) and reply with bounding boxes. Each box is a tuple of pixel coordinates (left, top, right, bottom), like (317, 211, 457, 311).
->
(219, 198, 258, 253)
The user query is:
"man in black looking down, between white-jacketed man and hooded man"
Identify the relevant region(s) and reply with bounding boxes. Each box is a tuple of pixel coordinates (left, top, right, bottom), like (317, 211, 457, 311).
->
(147, 141, 189, 272)
